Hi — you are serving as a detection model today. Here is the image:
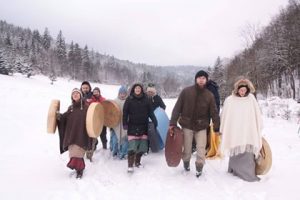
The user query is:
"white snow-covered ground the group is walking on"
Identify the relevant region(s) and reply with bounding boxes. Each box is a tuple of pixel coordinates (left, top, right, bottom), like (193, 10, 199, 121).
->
(0, 75, 300, 200)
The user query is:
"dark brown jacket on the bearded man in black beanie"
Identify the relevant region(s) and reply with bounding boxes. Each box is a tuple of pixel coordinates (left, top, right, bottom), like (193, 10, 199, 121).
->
(170, 84, 220, 132)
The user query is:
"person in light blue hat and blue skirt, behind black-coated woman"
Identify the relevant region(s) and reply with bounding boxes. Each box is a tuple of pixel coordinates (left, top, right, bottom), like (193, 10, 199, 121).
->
(110, 86, 128, 159)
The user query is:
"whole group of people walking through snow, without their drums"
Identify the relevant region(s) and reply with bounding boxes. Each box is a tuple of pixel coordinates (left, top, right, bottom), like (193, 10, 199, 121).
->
(57, 70, 262, 181)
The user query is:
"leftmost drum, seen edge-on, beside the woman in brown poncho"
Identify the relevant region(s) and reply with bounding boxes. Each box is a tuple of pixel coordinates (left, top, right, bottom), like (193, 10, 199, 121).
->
(47, 99, 60, 134)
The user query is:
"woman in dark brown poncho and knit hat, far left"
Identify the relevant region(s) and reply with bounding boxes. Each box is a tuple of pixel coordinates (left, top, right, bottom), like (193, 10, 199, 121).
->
(57, 88, 92, 178)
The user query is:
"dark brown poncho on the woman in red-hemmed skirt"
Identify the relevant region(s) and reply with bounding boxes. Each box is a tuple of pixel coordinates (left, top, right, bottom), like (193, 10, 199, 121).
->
(58, 102, 92, 153)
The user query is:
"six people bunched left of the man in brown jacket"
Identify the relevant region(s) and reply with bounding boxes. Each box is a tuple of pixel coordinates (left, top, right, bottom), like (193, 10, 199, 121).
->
(57, 81, 166, 178)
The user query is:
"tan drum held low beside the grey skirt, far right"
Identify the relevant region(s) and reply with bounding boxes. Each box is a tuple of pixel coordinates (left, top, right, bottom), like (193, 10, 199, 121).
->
(255, 138, 272, 175)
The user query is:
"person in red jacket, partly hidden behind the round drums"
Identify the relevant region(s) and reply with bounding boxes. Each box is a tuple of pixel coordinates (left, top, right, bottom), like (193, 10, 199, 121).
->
(86, 87, 107, 161)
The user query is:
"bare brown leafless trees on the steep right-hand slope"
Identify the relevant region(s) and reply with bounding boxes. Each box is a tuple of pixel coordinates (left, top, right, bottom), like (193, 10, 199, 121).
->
(218, 0, 300, 99)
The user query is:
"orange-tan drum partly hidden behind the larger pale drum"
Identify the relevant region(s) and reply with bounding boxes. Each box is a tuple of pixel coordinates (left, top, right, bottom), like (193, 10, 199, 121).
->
(101, 100, 121, 128)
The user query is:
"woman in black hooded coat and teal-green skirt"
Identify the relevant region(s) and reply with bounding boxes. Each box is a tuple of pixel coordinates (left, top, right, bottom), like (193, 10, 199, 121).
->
(123, 83, 157, 172)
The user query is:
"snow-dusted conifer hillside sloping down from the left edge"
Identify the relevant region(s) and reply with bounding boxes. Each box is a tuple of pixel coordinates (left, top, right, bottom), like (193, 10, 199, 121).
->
(0, 20, 199, 97)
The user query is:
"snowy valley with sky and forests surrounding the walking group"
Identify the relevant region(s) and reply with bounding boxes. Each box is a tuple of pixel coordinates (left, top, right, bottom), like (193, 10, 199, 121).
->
(0, 0, 300, 200)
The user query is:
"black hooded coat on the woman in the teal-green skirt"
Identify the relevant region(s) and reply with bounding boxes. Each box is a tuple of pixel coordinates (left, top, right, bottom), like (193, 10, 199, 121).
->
(123, 84, 157, 136)
